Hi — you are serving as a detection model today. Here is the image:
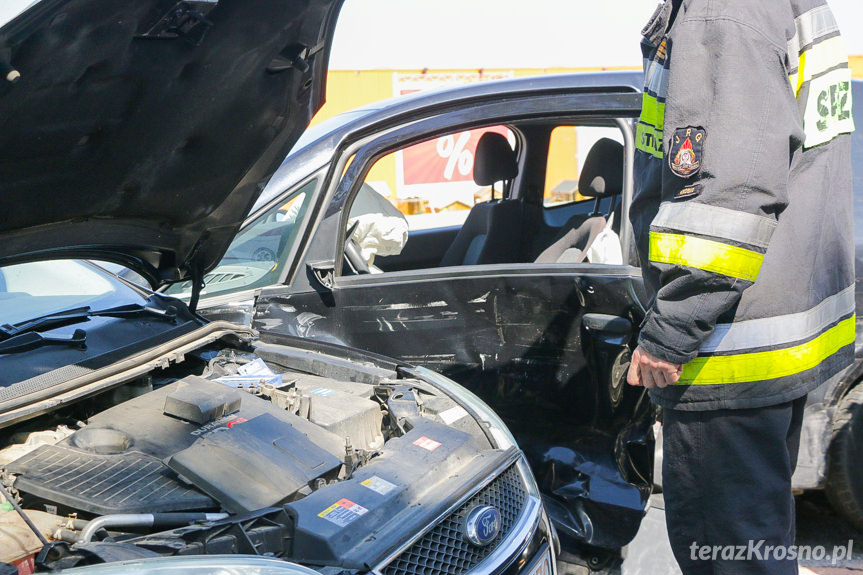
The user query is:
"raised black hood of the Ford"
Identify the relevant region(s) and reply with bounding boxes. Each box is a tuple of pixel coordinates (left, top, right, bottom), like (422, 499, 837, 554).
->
(0, 0, 342, 284)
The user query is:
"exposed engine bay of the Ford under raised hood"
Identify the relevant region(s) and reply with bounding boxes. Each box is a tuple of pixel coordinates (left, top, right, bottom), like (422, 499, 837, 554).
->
(0, 342, 512, 573)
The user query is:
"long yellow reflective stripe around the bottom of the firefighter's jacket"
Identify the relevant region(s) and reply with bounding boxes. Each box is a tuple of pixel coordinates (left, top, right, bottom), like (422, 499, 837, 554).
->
(677, 316, 855, 385)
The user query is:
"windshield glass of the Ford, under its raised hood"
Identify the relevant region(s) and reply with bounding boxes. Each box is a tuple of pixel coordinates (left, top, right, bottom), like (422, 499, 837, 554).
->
(0, 260, 146, 325)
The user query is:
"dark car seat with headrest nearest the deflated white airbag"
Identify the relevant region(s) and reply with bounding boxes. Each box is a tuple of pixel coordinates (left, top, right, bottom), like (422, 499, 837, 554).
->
(440, 132, 522, 266)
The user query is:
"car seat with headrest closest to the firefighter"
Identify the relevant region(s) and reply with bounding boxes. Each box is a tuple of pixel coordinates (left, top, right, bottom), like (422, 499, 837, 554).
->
(535, 138, 623, 263)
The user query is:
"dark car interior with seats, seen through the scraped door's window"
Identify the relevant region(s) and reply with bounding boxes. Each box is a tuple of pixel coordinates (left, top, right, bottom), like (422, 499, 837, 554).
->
(343, 121, 624, 275)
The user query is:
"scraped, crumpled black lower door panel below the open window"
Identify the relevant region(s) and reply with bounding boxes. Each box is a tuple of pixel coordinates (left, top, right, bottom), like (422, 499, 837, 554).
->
(255, 265, 652, 548)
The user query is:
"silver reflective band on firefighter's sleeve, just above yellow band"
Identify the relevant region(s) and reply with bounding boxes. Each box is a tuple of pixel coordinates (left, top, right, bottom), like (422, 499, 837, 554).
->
(650, 202, 776, 248)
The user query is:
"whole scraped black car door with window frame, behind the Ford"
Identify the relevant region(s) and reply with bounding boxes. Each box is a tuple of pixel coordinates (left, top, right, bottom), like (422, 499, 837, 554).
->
(246, 90, 652, 549)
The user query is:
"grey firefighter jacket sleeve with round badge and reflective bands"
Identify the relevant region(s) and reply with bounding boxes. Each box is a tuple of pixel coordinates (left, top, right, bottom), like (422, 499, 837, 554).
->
(639, 15, 802, 363)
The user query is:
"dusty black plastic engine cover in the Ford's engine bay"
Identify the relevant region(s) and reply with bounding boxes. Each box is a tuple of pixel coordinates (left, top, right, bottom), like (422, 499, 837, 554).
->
(7, 376, 344, 514)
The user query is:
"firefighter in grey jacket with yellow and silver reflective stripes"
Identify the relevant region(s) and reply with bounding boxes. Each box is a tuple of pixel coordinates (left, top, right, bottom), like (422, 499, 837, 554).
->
(628, 0, 855, 575)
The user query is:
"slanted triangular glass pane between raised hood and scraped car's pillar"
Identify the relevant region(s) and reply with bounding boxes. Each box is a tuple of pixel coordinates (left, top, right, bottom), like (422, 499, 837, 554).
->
(165, 179, 317, 297)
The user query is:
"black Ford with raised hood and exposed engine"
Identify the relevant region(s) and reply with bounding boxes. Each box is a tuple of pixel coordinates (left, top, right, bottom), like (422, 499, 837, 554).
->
(0, 0, 557, 575)
